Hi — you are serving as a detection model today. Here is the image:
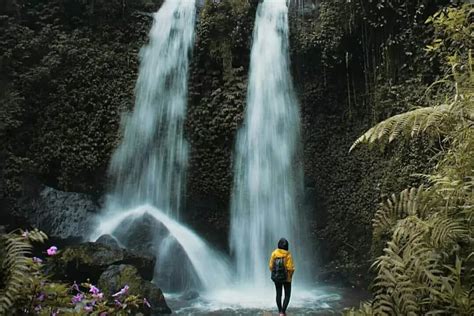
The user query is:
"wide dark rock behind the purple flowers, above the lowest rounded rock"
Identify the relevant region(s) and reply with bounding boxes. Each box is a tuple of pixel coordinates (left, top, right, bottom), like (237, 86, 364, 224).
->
(47, 242, 155, 282)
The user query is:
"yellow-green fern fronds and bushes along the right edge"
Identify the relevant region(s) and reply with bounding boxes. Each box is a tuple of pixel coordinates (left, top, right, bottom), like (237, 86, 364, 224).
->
(347, 7, 474, 315)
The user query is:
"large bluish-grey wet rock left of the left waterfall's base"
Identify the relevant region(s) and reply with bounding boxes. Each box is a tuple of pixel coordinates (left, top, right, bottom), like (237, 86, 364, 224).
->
(20, 187, 99, 240)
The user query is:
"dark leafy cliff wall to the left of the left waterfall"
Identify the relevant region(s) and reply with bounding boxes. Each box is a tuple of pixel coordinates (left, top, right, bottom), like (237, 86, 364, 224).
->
(0, 0, 159, 197)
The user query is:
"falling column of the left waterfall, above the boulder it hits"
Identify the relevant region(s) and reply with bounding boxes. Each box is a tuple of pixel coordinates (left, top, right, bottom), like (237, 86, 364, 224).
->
(106, 0, 196, 217)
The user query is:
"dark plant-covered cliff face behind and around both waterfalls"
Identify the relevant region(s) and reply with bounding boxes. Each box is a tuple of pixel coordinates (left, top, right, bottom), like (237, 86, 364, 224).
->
(0, 0, 440, 286)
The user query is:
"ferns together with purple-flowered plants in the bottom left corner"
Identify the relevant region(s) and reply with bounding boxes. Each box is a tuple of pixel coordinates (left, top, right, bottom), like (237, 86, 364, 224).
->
(0, 229, 149, 316)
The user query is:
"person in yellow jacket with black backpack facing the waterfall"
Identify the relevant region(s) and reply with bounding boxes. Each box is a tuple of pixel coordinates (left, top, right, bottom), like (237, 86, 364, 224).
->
(268, 238, 295, 316)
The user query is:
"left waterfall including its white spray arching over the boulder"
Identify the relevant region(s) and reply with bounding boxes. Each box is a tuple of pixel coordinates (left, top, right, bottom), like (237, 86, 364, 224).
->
(92, 0, 222, 290)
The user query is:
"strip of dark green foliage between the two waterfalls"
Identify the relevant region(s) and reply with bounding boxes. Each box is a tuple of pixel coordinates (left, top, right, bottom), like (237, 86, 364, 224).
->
(186, 0, 256, 199)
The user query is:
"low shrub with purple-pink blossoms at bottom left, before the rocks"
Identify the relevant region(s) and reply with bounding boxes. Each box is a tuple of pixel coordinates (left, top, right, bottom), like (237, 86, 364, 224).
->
(0, 231, 151, 316)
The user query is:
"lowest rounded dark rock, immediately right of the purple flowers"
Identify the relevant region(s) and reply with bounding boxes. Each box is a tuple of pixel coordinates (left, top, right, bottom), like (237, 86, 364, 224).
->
(98, 264, 171, 315)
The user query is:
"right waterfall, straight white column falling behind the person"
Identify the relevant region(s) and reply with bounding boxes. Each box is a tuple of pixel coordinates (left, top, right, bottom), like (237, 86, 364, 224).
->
(230, 0, 303, 288)
